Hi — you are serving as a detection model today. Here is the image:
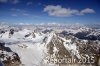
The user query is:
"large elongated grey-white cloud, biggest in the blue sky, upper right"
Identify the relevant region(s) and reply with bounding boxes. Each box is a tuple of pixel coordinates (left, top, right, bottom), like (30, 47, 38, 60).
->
(44, 5, 95, 17)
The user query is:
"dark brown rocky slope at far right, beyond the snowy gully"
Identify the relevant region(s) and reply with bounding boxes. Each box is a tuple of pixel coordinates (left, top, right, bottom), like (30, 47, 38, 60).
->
(78, 40, 100, 66)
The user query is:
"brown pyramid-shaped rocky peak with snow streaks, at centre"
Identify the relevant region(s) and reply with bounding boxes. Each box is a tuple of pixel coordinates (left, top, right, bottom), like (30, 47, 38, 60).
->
(43, 34, 72, 65)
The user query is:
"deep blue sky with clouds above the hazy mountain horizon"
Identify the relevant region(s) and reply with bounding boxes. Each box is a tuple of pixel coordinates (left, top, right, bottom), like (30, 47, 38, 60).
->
(0, 0, 100, 24)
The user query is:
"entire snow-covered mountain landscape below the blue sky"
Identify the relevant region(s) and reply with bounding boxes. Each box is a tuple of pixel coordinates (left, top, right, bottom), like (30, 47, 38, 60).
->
(0, 23, 100, 66)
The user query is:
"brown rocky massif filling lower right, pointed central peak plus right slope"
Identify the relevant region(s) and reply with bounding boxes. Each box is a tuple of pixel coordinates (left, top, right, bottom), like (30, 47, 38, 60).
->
(45, 34, 100, 66)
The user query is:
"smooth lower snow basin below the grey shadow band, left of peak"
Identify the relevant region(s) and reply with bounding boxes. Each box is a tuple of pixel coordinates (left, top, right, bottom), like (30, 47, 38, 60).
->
(6, 43, 44, 66)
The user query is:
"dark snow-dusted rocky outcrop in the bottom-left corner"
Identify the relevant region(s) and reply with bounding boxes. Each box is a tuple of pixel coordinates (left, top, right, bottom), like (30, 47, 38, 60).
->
(0, 43, 21, 66)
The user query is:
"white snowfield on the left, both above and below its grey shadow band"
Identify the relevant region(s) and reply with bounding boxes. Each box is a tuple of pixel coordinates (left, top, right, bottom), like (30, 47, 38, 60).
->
(0, 29, 46, 66)
